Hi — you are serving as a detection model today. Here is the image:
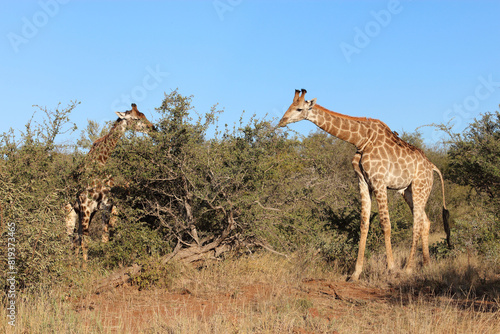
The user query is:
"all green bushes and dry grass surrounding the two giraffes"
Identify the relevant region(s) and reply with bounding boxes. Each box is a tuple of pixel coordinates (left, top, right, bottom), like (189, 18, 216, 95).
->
(0, 91, 500, 333)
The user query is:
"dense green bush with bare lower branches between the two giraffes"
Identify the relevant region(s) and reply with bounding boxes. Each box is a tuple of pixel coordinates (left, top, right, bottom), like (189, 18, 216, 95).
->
(101, 91, 364, 263)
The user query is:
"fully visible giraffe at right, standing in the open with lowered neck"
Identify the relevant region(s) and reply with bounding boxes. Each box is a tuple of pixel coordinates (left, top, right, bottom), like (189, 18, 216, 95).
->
(278, 89, 451, 281)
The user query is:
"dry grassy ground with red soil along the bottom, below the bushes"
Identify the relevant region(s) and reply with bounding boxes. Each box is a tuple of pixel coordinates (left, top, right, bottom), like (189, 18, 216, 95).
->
(0, 247, 500, 333)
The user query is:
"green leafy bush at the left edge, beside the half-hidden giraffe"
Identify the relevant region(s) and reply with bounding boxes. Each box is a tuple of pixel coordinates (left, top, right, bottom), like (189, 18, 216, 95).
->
(0, 102, 79, 287)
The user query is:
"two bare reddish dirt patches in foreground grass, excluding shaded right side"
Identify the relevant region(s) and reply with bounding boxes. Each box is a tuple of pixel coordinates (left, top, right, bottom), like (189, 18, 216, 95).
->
(72, 279, 391, 333)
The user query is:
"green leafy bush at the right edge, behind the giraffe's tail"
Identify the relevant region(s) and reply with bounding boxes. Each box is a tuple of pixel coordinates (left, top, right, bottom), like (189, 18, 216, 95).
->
(430, 111, 500, 265)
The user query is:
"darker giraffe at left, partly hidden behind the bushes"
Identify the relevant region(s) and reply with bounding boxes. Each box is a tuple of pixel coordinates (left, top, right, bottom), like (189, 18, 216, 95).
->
(65, 103, 154, 261)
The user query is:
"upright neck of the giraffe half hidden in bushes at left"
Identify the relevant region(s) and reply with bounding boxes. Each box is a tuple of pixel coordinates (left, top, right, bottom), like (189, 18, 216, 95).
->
(87, 118, 126, 166)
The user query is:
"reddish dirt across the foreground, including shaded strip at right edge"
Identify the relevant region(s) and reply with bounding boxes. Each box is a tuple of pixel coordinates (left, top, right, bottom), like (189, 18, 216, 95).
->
(71, 278, 499, 333)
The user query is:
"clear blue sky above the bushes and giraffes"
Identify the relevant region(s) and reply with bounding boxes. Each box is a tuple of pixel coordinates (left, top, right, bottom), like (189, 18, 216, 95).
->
(0, 0, 500, 143)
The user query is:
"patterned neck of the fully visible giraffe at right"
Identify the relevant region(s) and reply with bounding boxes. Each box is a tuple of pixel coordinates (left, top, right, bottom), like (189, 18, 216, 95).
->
(307, 104, 378, 151)
